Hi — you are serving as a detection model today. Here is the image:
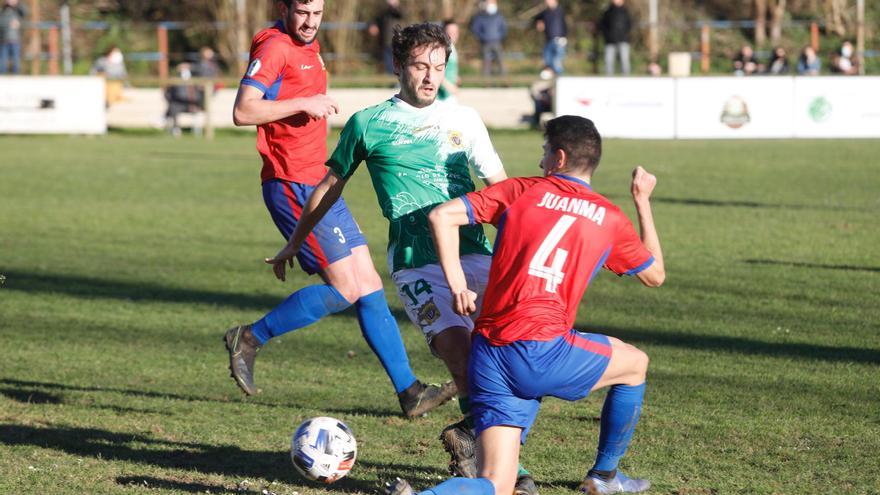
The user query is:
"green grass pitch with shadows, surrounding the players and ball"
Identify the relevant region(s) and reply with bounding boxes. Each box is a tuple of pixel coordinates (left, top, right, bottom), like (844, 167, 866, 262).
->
(0, 132, 880, 495)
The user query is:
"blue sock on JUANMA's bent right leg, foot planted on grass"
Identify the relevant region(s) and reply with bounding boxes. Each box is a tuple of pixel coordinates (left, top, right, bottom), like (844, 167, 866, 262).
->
(592, 383, 645, 471)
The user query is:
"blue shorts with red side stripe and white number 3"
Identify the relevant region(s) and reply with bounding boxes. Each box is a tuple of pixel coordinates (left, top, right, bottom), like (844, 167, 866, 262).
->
(263, 179, 367, 275)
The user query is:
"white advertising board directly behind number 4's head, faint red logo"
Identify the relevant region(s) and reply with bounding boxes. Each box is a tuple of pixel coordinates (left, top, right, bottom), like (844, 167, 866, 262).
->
(556, 77, 675, 139)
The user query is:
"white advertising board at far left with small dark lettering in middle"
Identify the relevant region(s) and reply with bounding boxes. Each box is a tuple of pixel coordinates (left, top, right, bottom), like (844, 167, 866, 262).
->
(0, 76, 107, 134)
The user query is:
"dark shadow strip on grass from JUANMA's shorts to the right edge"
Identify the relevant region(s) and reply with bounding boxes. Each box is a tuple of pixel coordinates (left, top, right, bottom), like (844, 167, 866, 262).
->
(592, 325, 880, 364)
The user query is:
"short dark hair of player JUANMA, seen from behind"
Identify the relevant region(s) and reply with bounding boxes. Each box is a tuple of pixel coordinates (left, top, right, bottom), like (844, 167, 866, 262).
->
(544, 115, 602, 172)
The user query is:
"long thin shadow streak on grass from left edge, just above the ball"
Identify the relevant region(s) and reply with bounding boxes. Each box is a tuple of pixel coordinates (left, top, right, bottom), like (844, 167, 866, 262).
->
(0, 378, 400, 418)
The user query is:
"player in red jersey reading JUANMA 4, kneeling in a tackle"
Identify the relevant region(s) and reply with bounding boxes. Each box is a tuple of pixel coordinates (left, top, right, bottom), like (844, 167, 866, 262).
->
(388, 116, 665, 495)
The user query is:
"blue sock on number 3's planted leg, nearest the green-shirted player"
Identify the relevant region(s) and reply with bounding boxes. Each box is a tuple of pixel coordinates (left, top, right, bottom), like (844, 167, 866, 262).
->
(355, 289, 416, 394)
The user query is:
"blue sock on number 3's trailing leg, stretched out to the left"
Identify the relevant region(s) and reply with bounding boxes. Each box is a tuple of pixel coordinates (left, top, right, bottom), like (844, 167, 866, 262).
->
(251, 285, 351, 344)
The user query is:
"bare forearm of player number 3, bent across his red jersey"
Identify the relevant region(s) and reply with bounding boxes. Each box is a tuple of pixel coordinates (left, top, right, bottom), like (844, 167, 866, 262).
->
(232, 84, 339, 126)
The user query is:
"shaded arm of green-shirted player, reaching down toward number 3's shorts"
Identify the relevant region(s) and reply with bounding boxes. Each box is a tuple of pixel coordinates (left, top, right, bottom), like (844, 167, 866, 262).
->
(265, 170, 346, 281)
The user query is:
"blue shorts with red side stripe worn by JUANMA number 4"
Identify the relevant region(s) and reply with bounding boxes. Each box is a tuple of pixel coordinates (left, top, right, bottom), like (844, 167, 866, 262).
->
(468, 330, 611, 443)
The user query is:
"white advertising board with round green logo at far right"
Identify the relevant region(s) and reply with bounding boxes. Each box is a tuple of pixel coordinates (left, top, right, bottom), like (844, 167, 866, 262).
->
(794, 76, 880, 138)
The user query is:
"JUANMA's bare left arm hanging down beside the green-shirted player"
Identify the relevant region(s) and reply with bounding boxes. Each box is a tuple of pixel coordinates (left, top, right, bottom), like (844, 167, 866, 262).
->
(428, 198, 477, 316)
